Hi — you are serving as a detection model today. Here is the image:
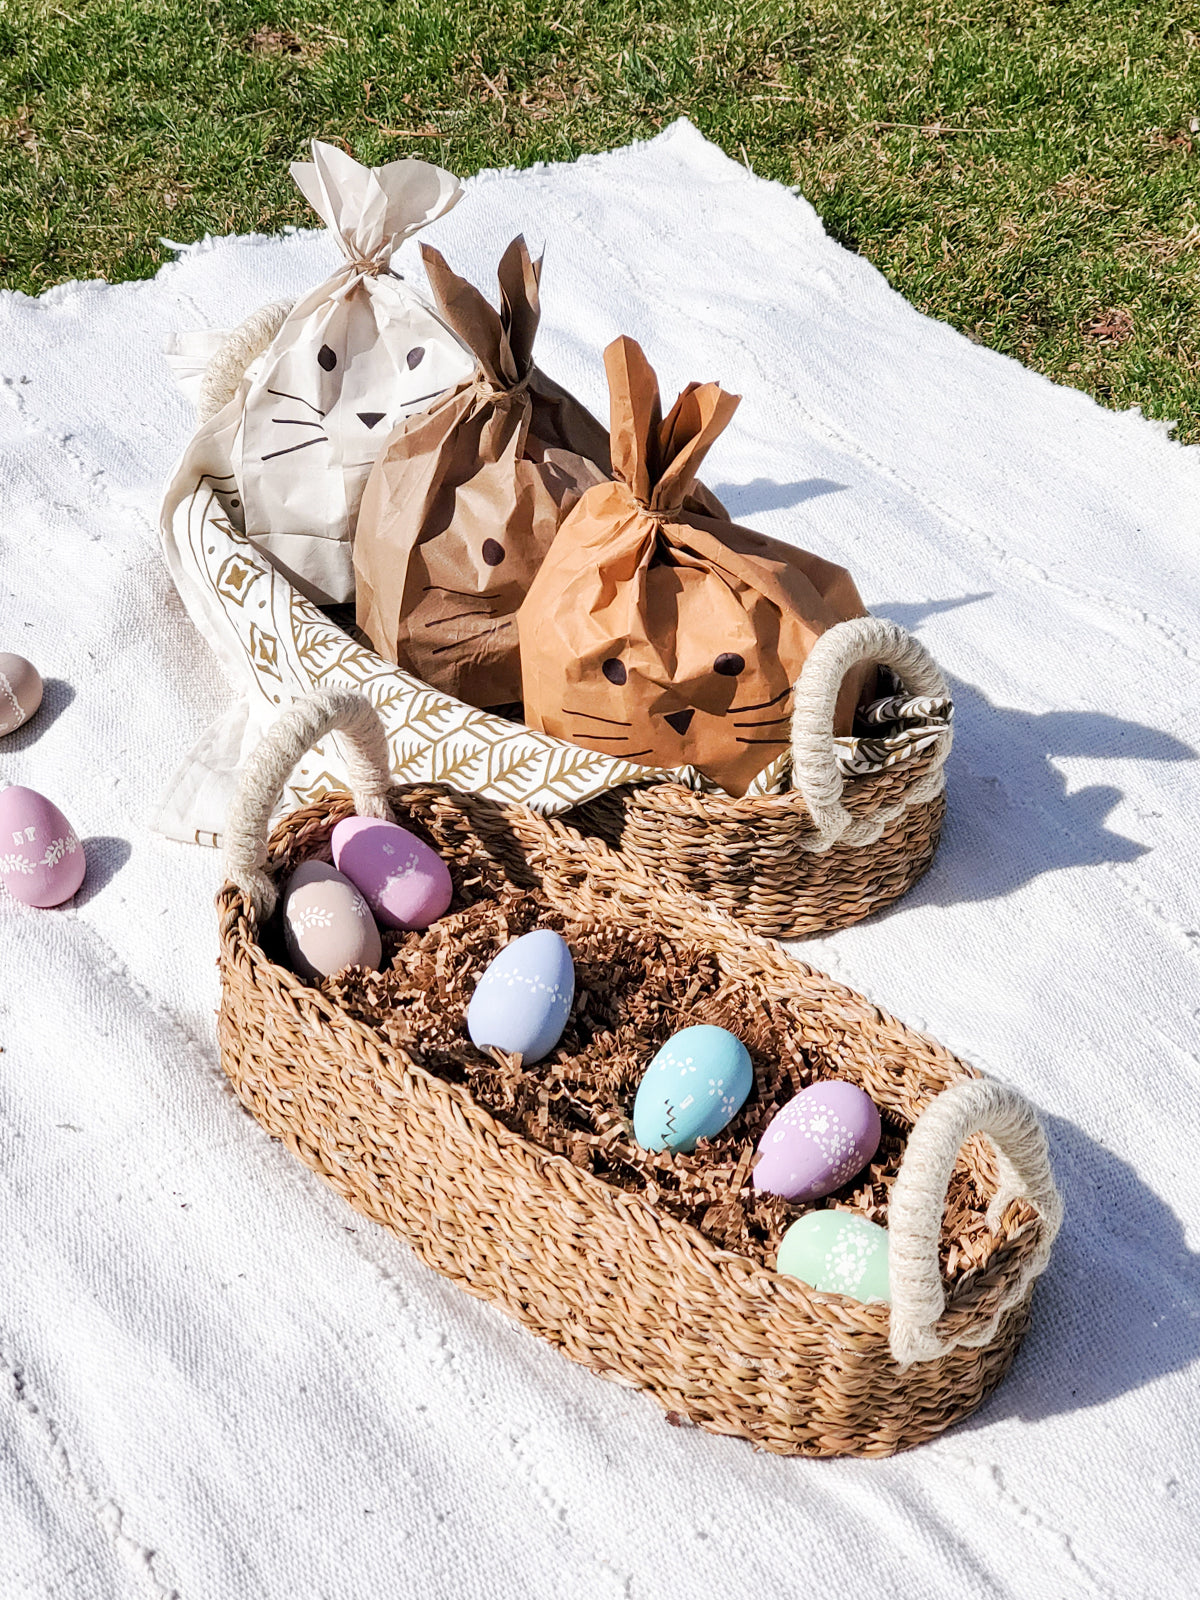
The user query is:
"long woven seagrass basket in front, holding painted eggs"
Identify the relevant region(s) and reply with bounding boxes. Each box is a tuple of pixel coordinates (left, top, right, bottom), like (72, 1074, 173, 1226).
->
(218, 691, 1061, 1456)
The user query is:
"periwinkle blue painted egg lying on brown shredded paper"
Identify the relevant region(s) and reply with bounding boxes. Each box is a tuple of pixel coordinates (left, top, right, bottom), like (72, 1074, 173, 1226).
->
(467, 928, 574, 1061)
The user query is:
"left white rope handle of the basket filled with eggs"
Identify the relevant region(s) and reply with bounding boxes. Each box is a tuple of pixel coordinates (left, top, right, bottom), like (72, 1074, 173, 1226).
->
(226, 688, 392, 923)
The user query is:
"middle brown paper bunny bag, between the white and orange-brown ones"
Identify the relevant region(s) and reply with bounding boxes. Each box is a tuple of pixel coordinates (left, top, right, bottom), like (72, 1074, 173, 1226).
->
(354, 238, 610, 706)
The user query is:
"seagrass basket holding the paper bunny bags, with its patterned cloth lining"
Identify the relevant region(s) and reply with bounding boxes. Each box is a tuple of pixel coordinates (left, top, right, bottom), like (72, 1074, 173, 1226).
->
(190, 302, 952, 939)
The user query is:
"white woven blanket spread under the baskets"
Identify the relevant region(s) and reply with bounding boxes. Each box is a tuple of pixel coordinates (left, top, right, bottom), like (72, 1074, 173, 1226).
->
(0, 123, 1200, 1600)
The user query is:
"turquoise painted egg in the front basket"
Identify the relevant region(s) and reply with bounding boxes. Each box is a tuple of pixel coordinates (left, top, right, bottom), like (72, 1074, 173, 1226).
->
(634, 1022, 754, 1155)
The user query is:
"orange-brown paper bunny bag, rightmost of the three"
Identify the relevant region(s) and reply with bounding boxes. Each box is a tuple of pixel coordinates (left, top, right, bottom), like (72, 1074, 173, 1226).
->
(518, 339, 875, 795)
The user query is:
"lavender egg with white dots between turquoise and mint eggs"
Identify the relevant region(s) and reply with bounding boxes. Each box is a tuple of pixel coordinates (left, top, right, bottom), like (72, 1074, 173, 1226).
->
(754, 1078, 882, 1205)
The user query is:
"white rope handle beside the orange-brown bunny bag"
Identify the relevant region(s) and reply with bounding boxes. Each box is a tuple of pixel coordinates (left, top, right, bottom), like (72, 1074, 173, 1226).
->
(792, 616, 952, 854)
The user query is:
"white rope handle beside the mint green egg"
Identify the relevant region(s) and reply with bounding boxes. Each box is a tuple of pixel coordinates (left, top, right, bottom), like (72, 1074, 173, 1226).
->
(888, 1078, 1062, 1366)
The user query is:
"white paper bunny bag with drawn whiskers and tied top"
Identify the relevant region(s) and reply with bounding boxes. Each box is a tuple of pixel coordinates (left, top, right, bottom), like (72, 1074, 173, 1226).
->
(162, 139, 474, 605)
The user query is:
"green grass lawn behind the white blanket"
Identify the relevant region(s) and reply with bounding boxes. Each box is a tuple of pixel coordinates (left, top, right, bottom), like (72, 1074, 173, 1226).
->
(0, 0, 1200, 442)
